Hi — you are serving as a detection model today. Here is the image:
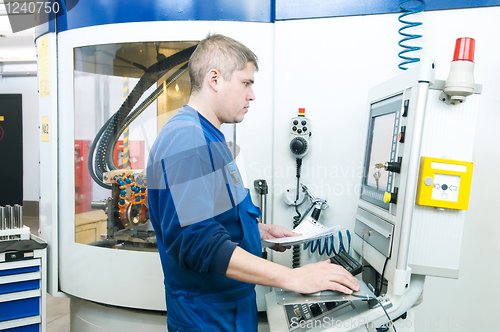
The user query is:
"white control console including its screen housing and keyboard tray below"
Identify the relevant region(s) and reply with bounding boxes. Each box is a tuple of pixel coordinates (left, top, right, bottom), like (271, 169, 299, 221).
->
(266, 59, 481, 332)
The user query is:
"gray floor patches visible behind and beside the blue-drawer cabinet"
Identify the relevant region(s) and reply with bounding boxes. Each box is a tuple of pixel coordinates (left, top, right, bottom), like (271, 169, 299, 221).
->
(23, 216, 70, 332)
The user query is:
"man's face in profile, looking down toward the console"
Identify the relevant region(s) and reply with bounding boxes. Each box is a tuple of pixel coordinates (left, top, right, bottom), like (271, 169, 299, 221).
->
(217, 62, 255, 123)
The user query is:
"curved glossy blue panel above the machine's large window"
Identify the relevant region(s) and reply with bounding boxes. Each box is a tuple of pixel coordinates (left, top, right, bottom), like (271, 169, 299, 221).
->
(57, 0, 274, 31)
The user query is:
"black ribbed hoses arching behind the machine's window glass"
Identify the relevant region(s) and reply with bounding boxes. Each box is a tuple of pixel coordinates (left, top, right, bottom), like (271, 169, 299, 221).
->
(88, 45, 197, 189)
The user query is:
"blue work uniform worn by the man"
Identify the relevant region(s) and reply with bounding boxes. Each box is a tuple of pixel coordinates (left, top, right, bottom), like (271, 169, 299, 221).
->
(147, 106, 262, 332)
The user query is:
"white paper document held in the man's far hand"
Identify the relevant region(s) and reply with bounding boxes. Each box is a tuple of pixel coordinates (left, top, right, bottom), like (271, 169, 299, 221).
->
(262, 218, 341, 248)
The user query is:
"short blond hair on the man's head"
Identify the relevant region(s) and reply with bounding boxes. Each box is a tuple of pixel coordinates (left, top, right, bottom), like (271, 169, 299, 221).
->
(189, 34, 259, 93)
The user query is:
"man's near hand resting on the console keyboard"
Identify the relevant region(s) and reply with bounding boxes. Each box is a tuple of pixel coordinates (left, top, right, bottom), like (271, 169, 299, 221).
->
(285, 259, 360, 294)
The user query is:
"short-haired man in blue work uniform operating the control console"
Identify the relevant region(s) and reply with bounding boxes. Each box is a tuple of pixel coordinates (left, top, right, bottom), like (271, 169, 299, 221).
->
(147, 35, 359, 331)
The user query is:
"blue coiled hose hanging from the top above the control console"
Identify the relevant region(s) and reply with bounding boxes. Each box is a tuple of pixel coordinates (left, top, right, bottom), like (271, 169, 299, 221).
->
(398, 0, 424, 70)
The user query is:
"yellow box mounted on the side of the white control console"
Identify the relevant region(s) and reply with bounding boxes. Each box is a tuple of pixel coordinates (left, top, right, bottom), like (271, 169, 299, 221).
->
(416, 157, 474, 210)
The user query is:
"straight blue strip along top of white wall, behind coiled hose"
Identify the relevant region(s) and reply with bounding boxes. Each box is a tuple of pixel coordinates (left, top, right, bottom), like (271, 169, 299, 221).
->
(276, 0, 500, 20)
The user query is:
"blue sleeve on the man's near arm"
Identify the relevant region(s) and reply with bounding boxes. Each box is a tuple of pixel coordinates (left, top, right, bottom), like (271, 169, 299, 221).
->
(148, 122, 237, 275)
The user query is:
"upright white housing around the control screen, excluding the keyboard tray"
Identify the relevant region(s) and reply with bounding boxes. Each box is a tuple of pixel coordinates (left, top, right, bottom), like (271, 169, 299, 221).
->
(353, 60, 481, 294)
